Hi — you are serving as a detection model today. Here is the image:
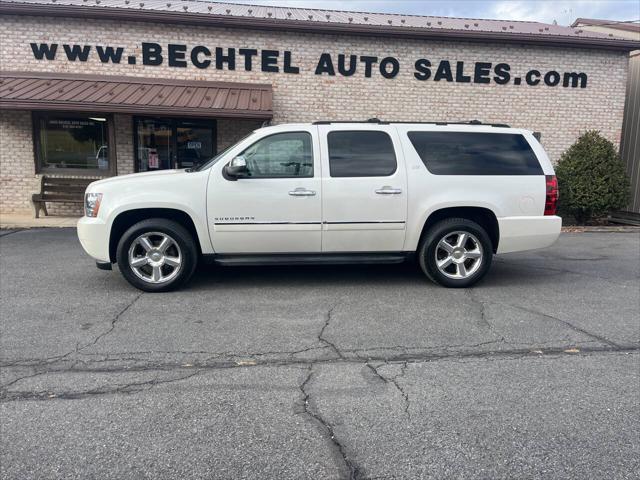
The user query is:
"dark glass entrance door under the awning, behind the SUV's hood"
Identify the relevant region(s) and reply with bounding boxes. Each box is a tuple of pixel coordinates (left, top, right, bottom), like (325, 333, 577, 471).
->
(134, 118, 216, 172)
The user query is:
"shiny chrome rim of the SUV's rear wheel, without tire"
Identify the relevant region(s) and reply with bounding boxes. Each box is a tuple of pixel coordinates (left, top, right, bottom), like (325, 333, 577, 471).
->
(435, 231, 484, 279)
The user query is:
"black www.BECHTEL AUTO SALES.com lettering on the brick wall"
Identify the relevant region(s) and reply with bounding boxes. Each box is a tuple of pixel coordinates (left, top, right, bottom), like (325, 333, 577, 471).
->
(31, 42, 587, 88)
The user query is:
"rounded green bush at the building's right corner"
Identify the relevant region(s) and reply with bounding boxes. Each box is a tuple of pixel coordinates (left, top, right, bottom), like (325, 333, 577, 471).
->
(555, 130, 629, 223)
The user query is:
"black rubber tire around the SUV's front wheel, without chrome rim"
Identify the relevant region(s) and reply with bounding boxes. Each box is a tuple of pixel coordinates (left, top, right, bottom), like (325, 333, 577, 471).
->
(116, 218, 198, 292)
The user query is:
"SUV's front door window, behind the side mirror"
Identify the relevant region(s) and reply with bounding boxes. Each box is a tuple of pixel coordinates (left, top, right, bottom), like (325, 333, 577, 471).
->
(241, 132, 313, 178)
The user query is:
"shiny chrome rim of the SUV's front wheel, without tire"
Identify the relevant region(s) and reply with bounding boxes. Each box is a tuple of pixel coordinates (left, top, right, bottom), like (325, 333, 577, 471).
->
(128, 232, 182, 284)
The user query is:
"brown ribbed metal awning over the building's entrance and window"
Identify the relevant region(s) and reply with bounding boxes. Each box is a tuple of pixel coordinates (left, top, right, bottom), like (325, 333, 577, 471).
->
(0, 71, 273, 119)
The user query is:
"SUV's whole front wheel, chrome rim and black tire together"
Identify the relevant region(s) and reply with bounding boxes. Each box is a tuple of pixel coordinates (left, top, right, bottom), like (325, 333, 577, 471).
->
(116, 218, 198, 292)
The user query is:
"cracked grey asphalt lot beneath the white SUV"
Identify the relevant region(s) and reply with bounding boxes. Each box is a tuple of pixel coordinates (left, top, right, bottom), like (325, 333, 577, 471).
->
(0, 229, 640, 479)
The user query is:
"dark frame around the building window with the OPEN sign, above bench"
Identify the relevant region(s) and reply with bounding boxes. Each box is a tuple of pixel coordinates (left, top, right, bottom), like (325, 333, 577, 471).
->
(31, 110, 118, 177)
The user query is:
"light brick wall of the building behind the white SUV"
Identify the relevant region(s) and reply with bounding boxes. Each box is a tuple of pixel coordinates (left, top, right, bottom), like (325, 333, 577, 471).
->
(0, 16, 628, 216)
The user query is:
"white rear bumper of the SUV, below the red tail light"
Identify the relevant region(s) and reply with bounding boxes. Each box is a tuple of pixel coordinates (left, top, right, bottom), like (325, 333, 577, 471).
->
(497, 215, 562, 253)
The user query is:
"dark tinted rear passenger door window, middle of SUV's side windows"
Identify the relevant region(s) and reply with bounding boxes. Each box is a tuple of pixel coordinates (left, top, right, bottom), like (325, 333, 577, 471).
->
(327, 131, 396, 177)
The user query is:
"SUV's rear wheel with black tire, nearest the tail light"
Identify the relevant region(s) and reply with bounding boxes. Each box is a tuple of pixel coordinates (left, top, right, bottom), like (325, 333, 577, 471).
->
(418, 218, 493, 288)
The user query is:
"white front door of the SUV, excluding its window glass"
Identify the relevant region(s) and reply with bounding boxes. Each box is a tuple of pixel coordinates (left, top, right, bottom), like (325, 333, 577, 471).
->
(207, 125, 322, 254)
